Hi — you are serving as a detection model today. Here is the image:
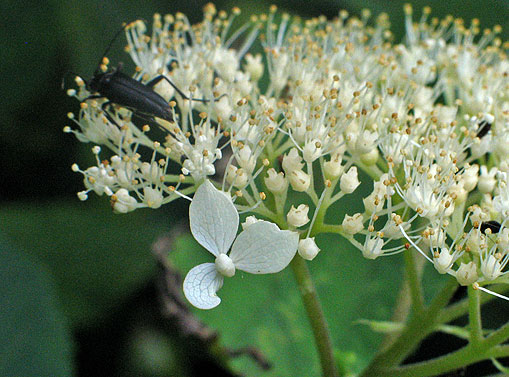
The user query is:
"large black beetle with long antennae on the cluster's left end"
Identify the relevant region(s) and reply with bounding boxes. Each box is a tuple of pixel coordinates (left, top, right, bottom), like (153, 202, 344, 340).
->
(73, 24, 208, 126)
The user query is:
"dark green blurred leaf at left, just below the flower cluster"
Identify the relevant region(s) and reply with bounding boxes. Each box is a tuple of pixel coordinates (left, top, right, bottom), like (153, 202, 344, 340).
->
(0, 200, 170, 326)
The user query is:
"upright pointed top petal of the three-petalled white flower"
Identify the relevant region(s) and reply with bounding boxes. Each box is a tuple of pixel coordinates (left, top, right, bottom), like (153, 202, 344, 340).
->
(189, 181, 239, 257)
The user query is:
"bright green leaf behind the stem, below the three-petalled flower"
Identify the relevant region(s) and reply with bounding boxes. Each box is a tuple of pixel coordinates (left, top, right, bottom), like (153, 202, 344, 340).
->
(171, 228, 402, 376)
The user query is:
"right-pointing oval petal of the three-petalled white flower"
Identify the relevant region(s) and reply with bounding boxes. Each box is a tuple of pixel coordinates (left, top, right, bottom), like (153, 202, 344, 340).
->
(230, 220, 299, 274)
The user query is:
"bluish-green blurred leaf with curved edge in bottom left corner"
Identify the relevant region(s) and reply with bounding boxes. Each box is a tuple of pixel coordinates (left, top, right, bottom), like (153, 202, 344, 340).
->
(0, 241, 72, 377)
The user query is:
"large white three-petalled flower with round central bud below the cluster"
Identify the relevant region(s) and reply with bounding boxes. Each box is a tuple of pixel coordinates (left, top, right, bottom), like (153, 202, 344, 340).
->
(184, 181, 299, 309)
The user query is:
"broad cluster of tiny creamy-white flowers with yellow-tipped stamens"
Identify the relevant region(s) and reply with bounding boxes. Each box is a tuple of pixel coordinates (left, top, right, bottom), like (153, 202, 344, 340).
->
(66, 4, 509, 306)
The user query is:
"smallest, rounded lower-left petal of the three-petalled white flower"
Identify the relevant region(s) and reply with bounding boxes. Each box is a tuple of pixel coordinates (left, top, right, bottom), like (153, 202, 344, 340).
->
(184, 263, 223, 309)
